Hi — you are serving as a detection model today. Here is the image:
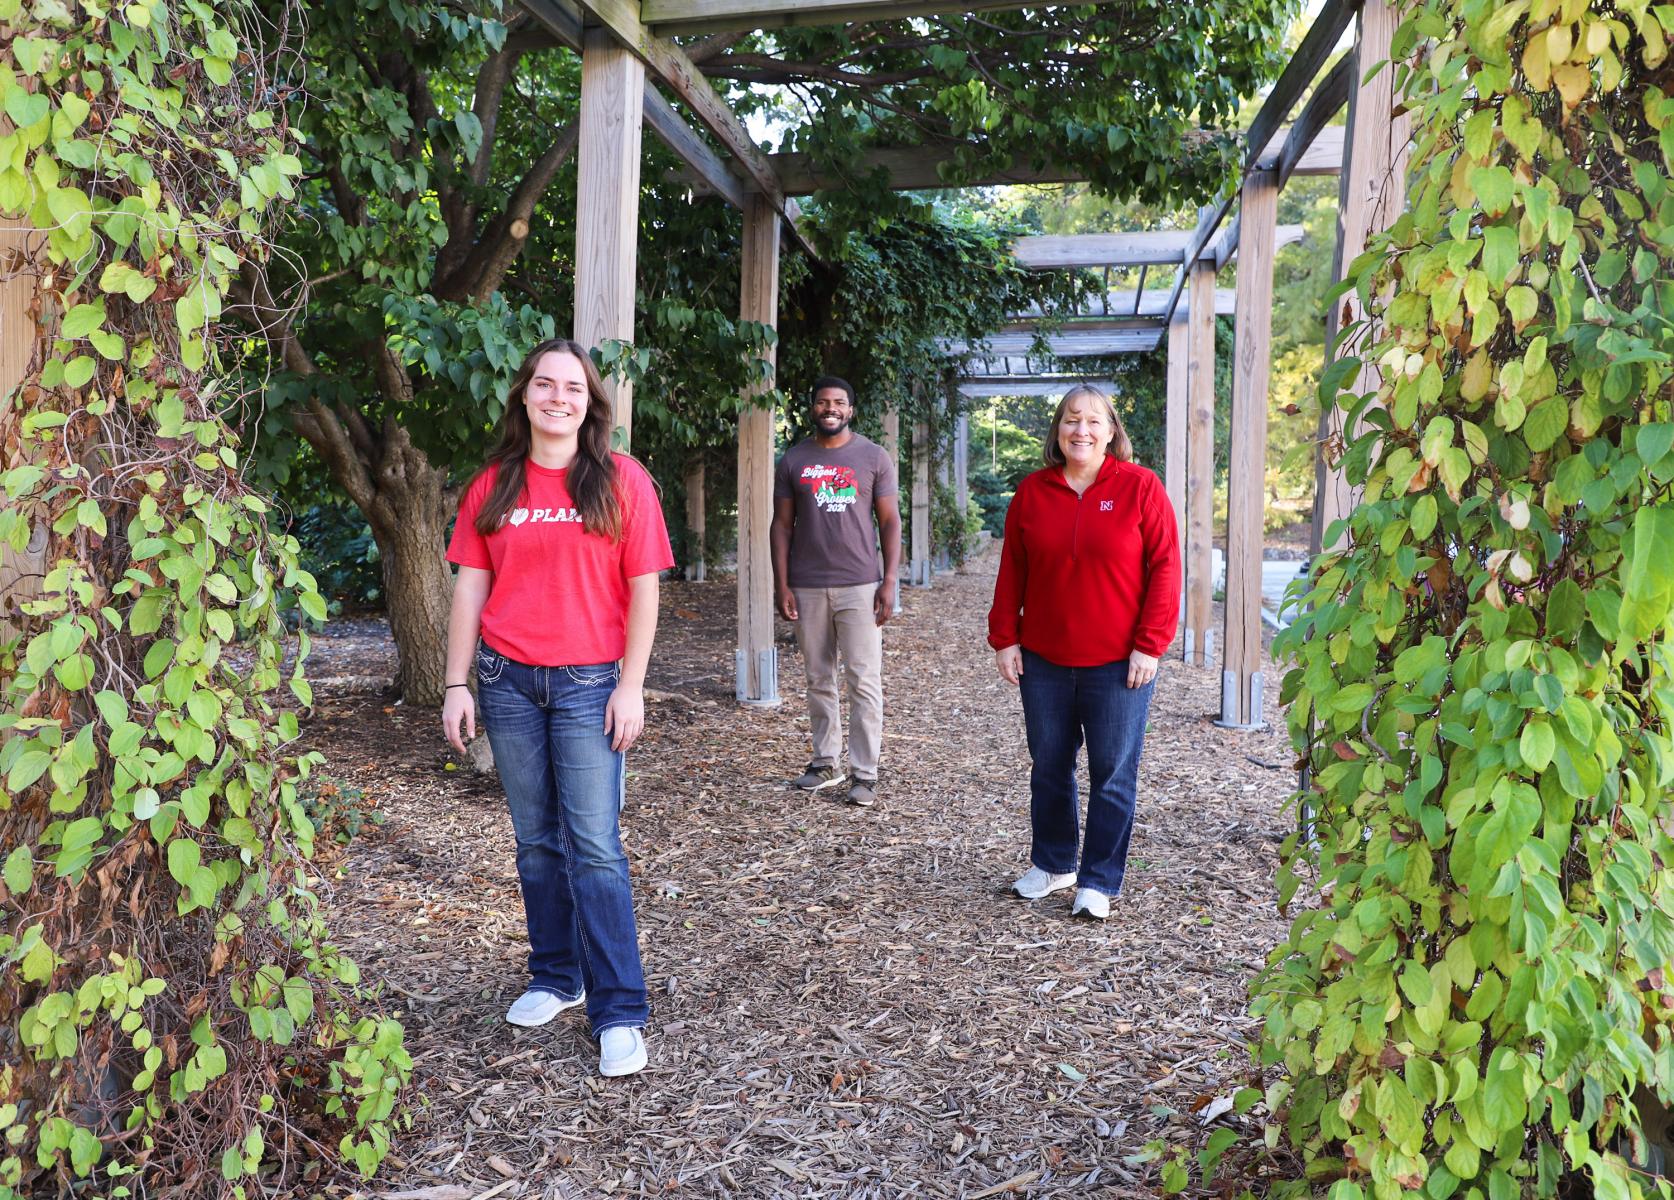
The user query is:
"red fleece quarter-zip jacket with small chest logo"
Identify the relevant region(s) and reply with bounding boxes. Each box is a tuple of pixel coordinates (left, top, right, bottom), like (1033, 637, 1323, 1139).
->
(988, 457, 1180, 666)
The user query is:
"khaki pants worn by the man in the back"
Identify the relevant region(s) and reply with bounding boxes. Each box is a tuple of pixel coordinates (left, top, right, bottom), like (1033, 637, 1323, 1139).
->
(792, 584, 884, 780)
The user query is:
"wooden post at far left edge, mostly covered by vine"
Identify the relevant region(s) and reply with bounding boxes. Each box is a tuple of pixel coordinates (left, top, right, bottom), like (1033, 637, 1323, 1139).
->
(0, 217, 49, 653)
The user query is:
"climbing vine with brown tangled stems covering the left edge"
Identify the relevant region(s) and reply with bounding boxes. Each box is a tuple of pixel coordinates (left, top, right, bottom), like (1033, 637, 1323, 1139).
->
(0, 0, 412, 1197)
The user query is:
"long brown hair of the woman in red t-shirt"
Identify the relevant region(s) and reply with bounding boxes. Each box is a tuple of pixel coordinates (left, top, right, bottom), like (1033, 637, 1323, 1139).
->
(477, 338, 623, 542)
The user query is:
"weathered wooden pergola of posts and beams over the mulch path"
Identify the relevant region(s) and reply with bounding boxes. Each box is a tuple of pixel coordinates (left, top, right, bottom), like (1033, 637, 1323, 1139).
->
(0, 0, 1406, 725)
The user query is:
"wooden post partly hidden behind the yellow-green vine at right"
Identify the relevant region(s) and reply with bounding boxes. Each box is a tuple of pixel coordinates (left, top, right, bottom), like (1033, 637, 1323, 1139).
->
(1309, 0, 1408, 554)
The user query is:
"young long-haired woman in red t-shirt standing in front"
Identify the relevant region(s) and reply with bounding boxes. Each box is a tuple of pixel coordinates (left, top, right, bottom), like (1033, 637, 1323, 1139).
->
(442, 338, 675, 1074)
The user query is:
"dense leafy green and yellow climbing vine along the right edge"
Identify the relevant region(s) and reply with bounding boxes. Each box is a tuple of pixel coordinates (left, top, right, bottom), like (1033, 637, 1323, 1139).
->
(1256, 0, 1674, 1200)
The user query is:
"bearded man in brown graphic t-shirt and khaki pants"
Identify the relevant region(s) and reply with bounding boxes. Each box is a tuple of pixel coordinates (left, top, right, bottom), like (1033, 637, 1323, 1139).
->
(772, 375, 901, 805)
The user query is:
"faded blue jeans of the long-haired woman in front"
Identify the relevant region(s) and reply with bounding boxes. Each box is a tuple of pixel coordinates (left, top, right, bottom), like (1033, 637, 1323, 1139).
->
(477, 646, 650, 1034)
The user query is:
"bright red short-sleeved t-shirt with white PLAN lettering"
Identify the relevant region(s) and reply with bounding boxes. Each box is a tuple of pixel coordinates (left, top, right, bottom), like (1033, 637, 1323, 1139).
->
(447, 454, 675, 666)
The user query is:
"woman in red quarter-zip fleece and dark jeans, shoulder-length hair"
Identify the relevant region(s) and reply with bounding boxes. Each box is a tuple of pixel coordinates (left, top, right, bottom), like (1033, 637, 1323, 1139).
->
(988, 383, 1180, 919)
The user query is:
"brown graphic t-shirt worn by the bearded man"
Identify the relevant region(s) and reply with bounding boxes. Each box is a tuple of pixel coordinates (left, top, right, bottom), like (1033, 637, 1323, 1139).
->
(773, 433, 899, 587)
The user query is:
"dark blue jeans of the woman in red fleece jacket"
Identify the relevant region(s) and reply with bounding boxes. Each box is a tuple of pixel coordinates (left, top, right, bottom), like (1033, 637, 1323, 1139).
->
(1019, 649, 1155, 895)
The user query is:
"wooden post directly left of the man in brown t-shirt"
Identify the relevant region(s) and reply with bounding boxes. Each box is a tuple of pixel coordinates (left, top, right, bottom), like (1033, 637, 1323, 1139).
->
(735, 192, 778, 705)
